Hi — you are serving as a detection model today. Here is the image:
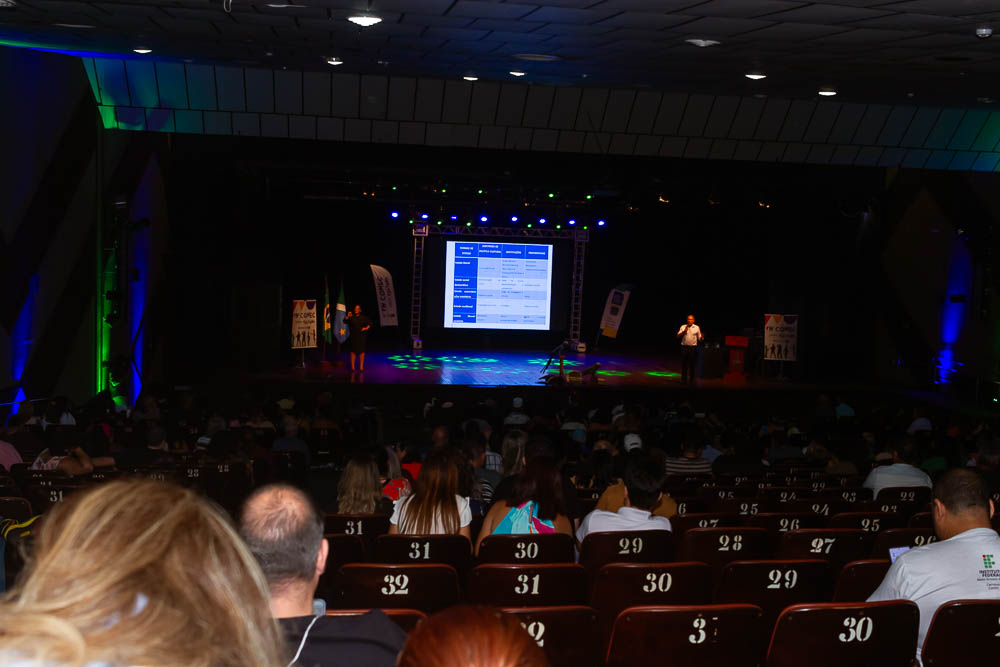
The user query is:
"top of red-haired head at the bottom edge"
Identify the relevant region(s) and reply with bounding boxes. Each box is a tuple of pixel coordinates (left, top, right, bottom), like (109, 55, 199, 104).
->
(396, 605, 549, 667)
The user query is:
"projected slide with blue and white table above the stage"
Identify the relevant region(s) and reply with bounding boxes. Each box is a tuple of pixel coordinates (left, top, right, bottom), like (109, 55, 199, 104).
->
(444, 241, 552, 331)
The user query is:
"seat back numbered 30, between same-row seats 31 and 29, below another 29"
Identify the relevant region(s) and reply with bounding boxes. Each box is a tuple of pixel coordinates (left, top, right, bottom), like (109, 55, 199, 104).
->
(590, 563, 712, 645)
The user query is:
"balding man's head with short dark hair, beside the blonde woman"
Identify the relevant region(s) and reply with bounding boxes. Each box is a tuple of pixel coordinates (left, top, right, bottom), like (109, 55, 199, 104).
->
(240, 484, 329, 618)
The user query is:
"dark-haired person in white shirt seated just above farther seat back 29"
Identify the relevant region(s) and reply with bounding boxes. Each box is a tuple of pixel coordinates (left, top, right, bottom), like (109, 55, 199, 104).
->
(576, 450, 670, 543)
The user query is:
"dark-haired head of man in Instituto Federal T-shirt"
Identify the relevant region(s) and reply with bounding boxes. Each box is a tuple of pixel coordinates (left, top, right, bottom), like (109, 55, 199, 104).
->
(931, 468, 993, 540)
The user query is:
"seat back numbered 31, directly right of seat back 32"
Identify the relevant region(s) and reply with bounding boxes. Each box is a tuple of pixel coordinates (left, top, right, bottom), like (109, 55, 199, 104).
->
(465, 563, 587, 607)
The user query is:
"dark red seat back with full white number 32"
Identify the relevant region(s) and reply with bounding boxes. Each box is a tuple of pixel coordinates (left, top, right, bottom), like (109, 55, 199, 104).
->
(336, 563, 458, 614)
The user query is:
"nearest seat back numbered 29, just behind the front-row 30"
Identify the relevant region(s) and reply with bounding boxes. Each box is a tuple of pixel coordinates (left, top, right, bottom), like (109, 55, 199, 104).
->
(715, 559, 833, 636)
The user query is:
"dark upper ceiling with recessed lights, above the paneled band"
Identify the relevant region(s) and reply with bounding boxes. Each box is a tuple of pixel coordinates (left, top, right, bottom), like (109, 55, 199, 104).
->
(0, 0, 1000, 106)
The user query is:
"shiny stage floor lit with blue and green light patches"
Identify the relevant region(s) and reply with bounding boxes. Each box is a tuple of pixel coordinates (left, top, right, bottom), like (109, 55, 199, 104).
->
(258, 350, 756, 388)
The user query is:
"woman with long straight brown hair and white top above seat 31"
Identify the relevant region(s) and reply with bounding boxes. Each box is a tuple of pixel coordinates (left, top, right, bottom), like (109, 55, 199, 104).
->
(389, 448, 472, 541)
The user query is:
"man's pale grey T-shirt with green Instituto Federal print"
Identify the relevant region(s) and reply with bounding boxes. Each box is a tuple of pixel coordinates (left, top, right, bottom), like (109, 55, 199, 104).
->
(868, 528, 1000, 659)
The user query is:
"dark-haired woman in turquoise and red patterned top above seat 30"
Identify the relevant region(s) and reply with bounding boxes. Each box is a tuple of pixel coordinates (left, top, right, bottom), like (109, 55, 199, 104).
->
(476, 457, 573, 554)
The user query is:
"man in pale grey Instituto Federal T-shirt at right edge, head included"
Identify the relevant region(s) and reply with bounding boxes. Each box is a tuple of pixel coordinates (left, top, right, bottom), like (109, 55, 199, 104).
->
(868, 468, 1000, 660)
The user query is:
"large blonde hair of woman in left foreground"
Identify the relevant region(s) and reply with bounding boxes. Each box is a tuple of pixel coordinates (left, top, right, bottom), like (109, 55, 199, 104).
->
(0, 479, 287, 667)
